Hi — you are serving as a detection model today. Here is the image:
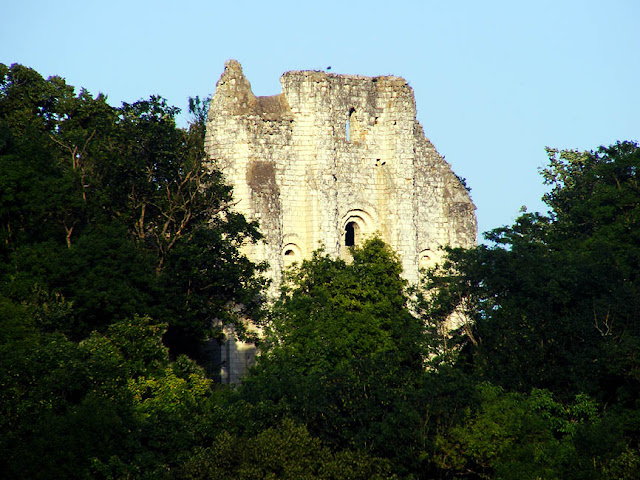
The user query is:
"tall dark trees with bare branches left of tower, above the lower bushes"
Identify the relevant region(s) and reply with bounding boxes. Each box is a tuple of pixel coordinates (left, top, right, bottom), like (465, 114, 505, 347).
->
(0, 65, 264, 348)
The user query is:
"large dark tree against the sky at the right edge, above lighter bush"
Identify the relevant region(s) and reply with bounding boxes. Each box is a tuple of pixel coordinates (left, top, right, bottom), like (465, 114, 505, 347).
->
(420, 143, 640, 401)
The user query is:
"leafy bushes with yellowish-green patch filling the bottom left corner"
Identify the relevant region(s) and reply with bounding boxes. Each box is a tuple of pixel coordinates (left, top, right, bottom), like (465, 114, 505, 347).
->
(0, 318, 218, 478)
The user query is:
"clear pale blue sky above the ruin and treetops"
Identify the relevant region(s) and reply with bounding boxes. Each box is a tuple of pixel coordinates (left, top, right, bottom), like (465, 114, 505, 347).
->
(0, 0, 640, 240)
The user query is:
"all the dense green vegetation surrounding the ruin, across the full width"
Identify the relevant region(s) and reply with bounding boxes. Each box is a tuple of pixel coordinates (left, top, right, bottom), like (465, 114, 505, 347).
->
(0, 65, 640, 479)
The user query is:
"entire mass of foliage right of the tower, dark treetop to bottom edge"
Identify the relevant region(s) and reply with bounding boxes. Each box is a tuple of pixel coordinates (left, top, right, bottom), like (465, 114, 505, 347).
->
(419, 142, 640, 478)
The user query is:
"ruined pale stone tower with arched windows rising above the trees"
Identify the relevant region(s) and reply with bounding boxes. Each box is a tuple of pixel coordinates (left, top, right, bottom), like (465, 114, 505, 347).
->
(206, 60, 477, 292)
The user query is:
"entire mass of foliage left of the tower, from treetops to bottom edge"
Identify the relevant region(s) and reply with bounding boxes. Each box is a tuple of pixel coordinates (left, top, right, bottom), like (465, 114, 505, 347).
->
(0, 65, 263, 478)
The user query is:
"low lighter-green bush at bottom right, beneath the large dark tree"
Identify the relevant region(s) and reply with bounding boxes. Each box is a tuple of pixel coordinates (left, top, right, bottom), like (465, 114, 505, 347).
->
(436, 384, 604, 480)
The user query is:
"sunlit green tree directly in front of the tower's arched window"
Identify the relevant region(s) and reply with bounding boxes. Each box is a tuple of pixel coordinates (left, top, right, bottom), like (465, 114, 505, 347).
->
(241, 238, 424, 469)
